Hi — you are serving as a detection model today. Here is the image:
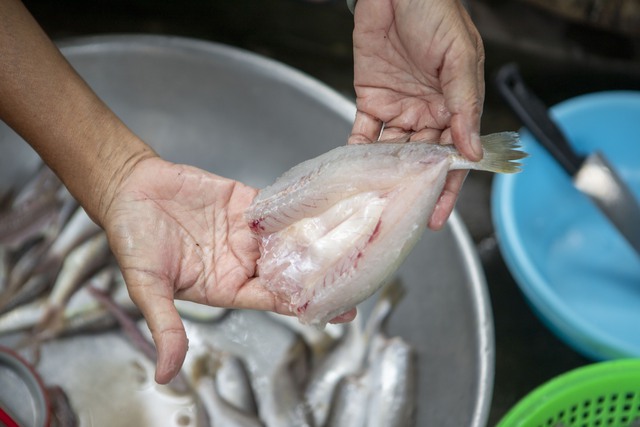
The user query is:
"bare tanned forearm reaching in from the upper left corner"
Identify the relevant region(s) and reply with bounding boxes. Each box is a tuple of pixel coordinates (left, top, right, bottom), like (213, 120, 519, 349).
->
(0, 0, 154, 223)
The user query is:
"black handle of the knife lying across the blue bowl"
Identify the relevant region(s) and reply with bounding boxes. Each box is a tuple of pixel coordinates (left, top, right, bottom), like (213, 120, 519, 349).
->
(496, 64, 584, 176)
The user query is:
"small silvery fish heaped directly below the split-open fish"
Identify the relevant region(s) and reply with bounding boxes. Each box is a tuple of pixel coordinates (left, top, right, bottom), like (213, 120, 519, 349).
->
(186, 282, 417, 427)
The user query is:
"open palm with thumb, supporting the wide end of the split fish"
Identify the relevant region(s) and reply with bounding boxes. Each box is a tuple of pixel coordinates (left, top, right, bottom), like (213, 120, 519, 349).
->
(102, 157, 289, 383)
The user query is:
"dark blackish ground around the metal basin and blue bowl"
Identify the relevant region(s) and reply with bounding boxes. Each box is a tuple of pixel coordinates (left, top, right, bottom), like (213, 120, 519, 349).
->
(18, 0, 640, 427)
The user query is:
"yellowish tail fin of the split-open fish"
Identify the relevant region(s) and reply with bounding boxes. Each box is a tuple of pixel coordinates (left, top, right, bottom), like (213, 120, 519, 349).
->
(471, 132, 528, 173)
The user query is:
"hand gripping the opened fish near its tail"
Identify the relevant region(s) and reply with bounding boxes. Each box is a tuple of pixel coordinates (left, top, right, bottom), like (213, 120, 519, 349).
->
(349, 0, 484, 229)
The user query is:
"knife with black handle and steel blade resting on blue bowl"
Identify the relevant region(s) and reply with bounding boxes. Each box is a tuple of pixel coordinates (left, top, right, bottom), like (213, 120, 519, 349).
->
(496, 64, 640, 256)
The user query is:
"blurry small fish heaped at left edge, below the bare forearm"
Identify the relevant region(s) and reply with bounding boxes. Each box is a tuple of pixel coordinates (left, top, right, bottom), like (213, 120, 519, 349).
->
(0, 166, 133, 340)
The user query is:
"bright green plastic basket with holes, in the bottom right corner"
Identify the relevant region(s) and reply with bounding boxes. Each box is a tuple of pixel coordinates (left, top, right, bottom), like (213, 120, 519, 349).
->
(498, 359, 640, 427)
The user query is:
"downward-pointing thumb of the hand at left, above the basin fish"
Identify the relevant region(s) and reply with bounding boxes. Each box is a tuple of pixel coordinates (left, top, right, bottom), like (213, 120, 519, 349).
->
(125, 274, 188, 384)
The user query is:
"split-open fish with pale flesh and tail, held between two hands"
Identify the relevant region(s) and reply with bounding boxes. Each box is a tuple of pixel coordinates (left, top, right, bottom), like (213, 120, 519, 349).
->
(246, 132, 526, 326)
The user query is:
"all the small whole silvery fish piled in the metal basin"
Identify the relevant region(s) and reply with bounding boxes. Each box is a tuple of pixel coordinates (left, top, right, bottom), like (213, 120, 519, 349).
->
(0, 162, 417, 427)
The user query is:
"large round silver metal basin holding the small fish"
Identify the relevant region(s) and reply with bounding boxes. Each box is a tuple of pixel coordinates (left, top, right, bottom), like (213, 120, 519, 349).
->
(0, 36, 494, 427)
